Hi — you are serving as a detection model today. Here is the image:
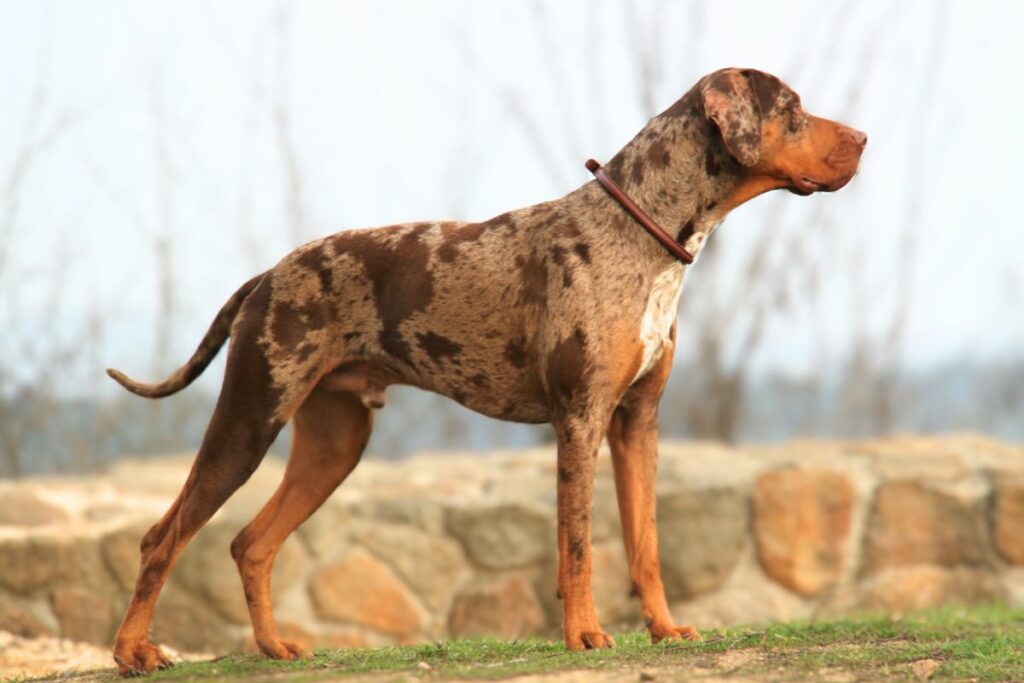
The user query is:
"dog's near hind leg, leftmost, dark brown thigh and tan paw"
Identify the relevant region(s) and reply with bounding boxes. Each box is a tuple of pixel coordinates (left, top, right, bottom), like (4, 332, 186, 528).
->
(114, 285, 296, 675)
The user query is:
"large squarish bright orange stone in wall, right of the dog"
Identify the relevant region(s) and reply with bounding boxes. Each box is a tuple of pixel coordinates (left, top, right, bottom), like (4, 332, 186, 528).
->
(754, 469, 854, 597)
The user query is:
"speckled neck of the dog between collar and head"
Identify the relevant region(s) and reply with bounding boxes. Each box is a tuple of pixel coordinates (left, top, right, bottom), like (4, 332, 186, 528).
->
(604, 94, 742, 260)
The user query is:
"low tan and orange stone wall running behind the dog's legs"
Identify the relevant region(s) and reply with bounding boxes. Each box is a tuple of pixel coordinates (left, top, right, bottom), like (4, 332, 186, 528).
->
(0, 435, 1024, 652)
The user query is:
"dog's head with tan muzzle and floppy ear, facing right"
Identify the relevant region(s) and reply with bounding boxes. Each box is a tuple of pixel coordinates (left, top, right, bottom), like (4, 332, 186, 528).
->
(696, 69, 867, 195)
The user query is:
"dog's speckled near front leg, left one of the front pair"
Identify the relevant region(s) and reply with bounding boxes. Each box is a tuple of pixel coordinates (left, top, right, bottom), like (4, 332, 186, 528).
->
(555, 418, 614, 650)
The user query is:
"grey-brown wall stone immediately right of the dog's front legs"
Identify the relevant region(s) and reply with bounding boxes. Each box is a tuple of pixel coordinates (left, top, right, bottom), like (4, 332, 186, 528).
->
(657, 488, 751, 600)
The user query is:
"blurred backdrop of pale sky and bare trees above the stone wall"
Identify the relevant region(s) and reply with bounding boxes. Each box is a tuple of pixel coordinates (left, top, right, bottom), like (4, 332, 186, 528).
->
(0, 0, 1024, 476)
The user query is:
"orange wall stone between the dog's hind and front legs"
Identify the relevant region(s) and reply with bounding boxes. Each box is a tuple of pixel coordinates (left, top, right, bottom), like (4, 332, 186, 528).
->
(309, 549, 423, 636)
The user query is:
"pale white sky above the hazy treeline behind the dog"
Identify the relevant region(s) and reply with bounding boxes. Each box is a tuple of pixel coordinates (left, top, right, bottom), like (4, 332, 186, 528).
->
(0, 0, 1024, 392)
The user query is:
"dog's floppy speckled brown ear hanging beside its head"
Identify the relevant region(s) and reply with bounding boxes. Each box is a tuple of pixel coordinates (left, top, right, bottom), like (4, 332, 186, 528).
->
(700, 69, 761, 166)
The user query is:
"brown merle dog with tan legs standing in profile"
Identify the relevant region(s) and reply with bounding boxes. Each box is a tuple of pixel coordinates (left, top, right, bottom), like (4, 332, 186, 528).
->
(108, 69, 867, 675)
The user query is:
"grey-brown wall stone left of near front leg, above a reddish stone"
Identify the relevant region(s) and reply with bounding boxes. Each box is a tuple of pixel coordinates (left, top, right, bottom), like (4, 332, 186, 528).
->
(447, 503, 555, 569)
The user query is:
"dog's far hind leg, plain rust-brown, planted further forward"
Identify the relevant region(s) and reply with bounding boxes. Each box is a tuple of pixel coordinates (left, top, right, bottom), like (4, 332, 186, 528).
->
(231, 389, 372, 659)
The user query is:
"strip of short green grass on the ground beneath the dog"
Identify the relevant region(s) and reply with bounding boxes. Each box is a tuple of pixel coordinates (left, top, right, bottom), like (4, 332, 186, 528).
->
(29, 606, 1024, 682)
